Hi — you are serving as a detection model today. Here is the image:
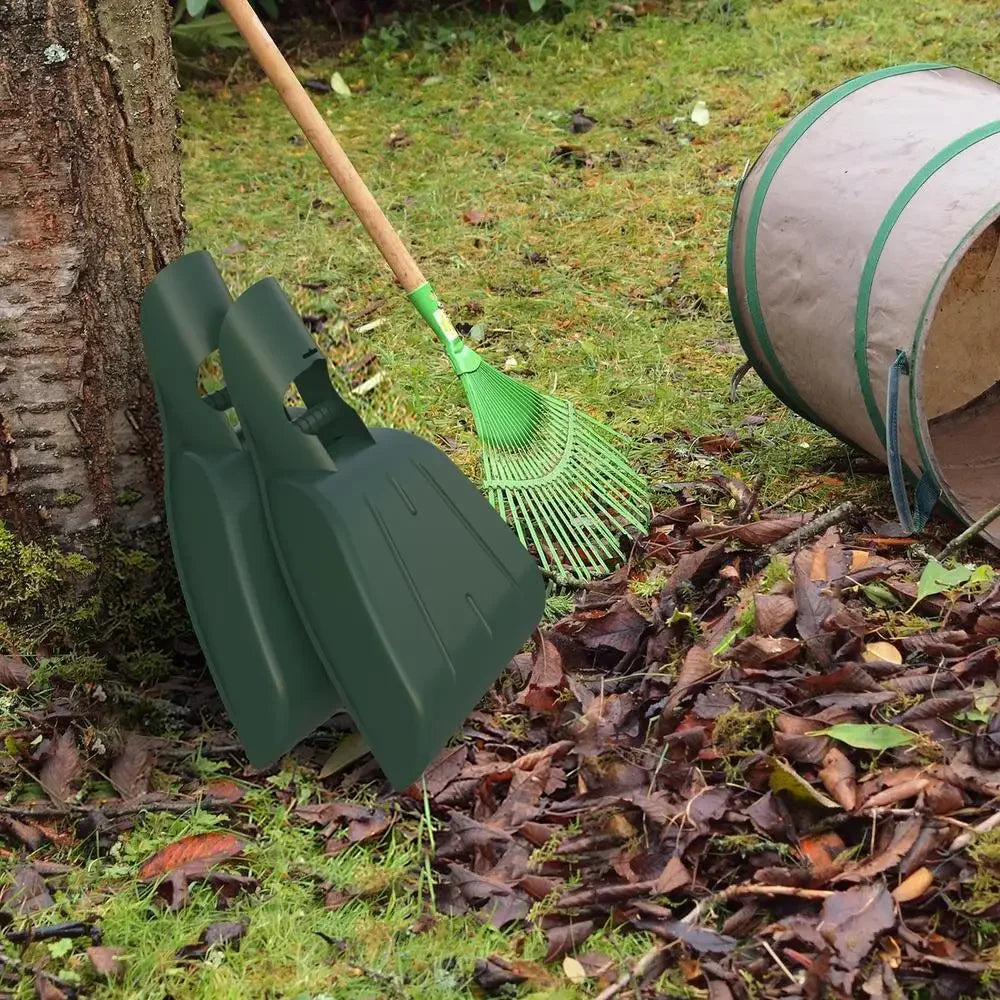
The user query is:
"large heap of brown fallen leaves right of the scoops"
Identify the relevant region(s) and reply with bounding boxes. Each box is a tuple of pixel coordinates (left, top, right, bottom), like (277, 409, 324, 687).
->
(408, 491, 1000, 998)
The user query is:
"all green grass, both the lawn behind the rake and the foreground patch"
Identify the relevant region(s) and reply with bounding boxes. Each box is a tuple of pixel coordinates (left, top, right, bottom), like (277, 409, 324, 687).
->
(0, 0, 1000, 1000)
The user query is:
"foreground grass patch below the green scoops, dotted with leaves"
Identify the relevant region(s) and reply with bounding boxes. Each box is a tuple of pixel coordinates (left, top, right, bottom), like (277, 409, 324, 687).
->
(0, 764, 649, 1000)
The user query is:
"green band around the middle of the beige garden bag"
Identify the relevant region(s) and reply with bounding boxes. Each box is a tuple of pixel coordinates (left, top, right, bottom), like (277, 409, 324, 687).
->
(854, 121, 1000, 445)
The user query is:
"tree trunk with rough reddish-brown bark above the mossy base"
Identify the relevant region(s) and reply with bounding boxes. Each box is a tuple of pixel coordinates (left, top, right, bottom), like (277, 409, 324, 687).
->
(0, 0, 184, 544)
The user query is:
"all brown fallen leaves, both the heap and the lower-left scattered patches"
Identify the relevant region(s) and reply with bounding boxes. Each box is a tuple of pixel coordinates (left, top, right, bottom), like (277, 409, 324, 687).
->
(0, 477, 1000, 1000)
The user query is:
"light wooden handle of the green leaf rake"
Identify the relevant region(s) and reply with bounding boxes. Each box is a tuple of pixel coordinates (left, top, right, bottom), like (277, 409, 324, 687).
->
(219, 0, 426, 294)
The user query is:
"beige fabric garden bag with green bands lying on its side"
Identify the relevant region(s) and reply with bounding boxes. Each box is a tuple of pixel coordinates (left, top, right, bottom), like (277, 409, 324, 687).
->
(727, 64, 1000, 546)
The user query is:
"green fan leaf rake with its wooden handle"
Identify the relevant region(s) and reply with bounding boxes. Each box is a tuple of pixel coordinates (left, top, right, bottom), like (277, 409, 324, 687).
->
(220, 0, 649, 579)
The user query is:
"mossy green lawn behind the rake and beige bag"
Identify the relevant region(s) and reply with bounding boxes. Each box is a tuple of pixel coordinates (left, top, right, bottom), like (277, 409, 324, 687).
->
(182, 0, 997, 505)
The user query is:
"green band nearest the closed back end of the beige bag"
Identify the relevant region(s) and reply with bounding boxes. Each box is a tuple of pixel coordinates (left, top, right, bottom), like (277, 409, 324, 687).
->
(737, 63, 958, 440)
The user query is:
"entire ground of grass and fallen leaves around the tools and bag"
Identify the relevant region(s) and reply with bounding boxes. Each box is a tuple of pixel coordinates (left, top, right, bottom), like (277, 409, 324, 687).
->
(0, 2, 1000, 1000)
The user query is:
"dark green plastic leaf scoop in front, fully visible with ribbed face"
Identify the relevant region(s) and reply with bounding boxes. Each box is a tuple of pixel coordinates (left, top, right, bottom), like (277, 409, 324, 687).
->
(219, 278, 545, 788)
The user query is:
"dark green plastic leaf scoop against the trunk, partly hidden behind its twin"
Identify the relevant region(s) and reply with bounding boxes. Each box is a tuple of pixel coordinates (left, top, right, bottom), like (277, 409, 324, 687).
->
(141, 252, 343, 767)
